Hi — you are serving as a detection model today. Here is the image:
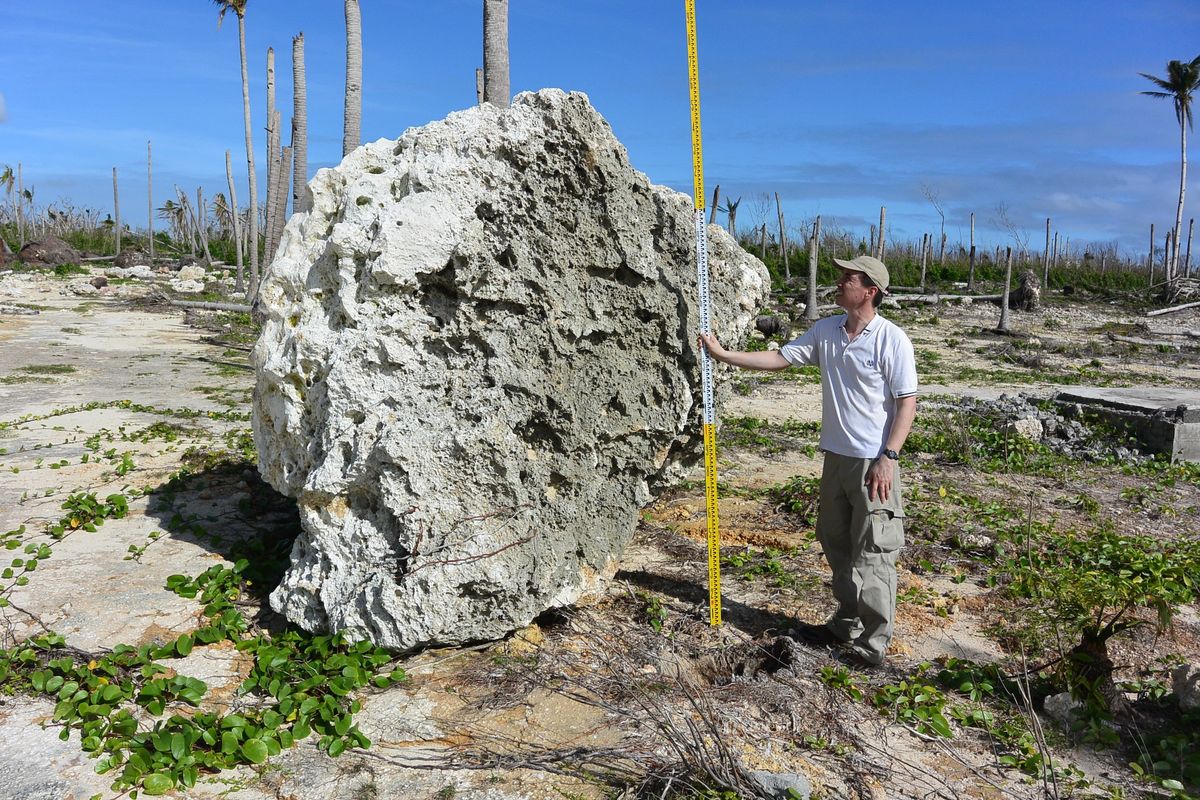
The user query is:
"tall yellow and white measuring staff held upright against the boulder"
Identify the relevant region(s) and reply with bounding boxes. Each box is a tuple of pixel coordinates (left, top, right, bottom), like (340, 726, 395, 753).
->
(684, 0, 721, 625)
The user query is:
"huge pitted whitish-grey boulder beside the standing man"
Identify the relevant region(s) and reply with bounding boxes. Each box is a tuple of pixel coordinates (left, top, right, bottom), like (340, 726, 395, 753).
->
(253, 90, 768, 649)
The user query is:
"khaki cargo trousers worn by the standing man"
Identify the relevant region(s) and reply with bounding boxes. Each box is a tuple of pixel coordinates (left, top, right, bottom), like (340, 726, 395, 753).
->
(817, 452, 904, 663)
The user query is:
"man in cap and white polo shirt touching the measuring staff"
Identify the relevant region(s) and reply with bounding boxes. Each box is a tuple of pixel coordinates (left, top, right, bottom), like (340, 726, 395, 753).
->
(700, 255, 917, 666)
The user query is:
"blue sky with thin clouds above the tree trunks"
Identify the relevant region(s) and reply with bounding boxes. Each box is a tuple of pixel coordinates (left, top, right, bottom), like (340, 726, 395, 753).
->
(0, 0, 1200, 259)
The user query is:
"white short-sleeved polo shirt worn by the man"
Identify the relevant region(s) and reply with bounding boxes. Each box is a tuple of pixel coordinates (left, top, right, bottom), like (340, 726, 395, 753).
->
(779, 314, 917, 458)
